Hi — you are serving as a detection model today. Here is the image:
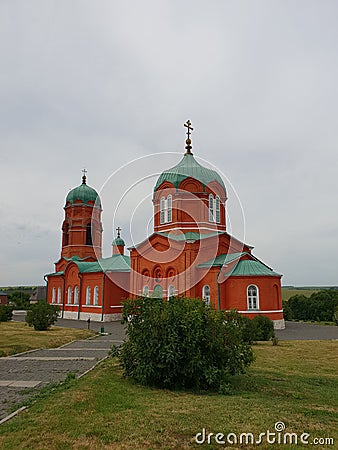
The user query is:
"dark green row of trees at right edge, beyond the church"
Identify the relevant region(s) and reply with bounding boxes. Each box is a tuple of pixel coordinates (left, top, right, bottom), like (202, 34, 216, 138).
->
(283, 289, 338, 324)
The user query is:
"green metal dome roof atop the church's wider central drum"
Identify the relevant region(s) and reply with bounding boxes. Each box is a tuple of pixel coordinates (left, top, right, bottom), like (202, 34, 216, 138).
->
(154, 153, 225, 191)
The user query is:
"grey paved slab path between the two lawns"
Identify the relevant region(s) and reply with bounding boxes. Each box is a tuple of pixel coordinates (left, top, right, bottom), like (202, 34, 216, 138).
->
(0, 327, 123, 420)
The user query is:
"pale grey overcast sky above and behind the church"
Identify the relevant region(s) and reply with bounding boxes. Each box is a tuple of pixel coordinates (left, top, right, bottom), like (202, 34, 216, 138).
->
(0, 0, 338, 286)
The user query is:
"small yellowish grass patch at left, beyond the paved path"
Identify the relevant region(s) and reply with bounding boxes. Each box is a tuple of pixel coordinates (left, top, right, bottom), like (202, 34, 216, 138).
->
(0, 322, 94, 356)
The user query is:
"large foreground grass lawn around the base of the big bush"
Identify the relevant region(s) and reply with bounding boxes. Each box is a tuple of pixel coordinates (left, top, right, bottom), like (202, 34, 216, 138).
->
(0, 341, 338, 450)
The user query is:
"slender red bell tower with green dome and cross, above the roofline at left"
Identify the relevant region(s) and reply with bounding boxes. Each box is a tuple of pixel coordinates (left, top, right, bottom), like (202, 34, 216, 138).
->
(61, 173, 102, 260)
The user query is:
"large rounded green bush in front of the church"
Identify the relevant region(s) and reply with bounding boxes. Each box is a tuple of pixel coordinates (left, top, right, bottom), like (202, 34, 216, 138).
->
(113, 297, 253, 389)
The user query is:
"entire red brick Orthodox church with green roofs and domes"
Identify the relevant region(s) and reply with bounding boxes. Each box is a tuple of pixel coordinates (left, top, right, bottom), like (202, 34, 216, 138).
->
(46, 121, 285, 329)
